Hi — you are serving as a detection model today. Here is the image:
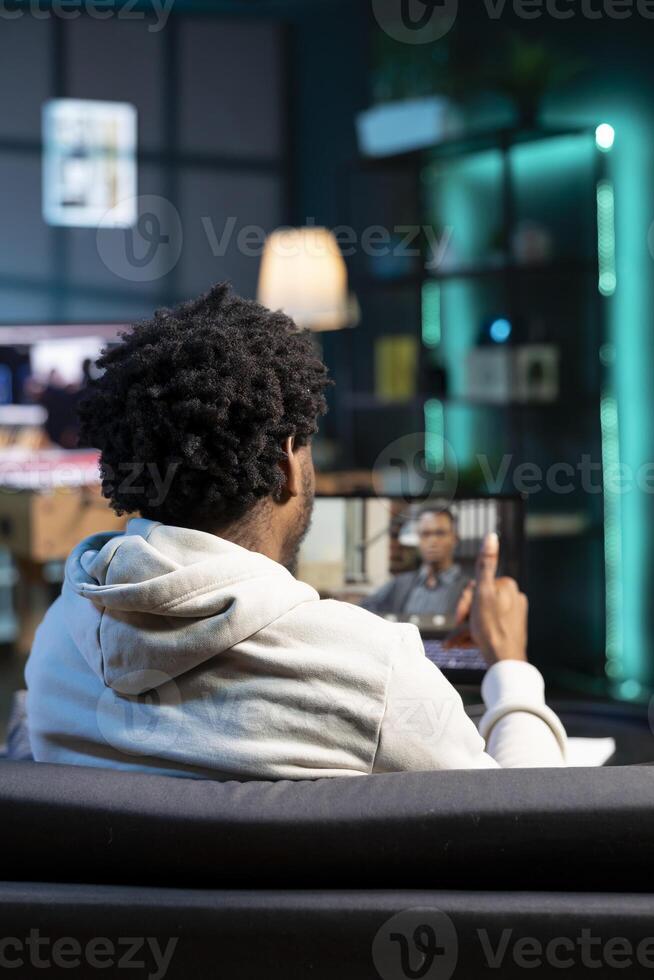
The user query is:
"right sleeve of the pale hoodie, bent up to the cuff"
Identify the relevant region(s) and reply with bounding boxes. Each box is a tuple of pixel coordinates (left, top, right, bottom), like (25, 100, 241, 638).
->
(373, 628, 566, 772)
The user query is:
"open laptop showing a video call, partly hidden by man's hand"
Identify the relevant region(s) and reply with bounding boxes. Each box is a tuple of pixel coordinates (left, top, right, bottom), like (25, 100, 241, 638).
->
(297, 494, 525, 685)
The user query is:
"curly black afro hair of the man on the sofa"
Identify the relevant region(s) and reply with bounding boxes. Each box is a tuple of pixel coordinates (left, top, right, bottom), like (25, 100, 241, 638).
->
(79, 283, 331, 528)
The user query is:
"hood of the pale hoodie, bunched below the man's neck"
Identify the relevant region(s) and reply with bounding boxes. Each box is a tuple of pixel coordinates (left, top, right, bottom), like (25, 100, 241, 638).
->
(62, 518, 319, 695)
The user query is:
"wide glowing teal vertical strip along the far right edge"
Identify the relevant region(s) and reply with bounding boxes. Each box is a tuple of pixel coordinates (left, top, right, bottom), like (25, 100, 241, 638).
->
(605, 115, 654, 698)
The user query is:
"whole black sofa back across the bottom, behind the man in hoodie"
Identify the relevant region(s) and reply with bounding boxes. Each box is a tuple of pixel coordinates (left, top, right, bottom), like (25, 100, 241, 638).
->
(0, 762, 654, 980)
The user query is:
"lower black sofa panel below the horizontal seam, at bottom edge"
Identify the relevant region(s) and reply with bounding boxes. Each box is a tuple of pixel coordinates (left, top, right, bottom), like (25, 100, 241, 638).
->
(0, 884, 654, 980)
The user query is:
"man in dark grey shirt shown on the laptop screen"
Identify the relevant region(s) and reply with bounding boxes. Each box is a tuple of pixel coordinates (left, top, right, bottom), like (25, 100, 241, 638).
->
(361, 508, 468, 616)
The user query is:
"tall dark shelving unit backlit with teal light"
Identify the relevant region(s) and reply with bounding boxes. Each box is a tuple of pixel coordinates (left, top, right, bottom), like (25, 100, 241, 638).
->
(331, 126, 606, 679)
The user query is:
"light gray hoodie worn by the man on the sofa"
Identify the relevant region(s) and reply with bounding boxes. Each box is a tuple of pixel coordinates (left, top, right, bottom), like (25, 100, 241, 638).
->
(26, 518, 565, 779)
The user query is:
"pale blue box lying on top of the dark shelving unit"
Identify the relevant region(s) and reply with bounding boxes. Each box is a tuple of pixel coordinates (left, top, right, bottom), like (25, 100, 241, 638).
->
(356, 95, 463, 157)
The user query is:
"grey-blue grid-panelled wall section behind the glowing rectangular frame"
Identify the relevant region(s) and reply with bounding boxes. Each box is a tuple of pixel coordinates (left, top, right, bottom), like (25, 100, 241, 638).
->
(0, 11, 290, 323)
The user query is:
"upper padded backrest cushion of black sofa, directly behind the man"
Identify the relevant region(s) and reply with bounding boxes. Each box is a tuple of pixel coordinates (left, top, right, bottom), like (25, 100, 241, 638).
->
(0, 762, 654, 891)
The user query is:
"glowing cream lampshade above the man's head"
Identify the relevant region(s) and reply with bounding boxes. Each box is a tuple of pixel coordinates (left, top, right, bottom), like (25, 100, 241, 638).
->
(258, 227, 352, 331)
